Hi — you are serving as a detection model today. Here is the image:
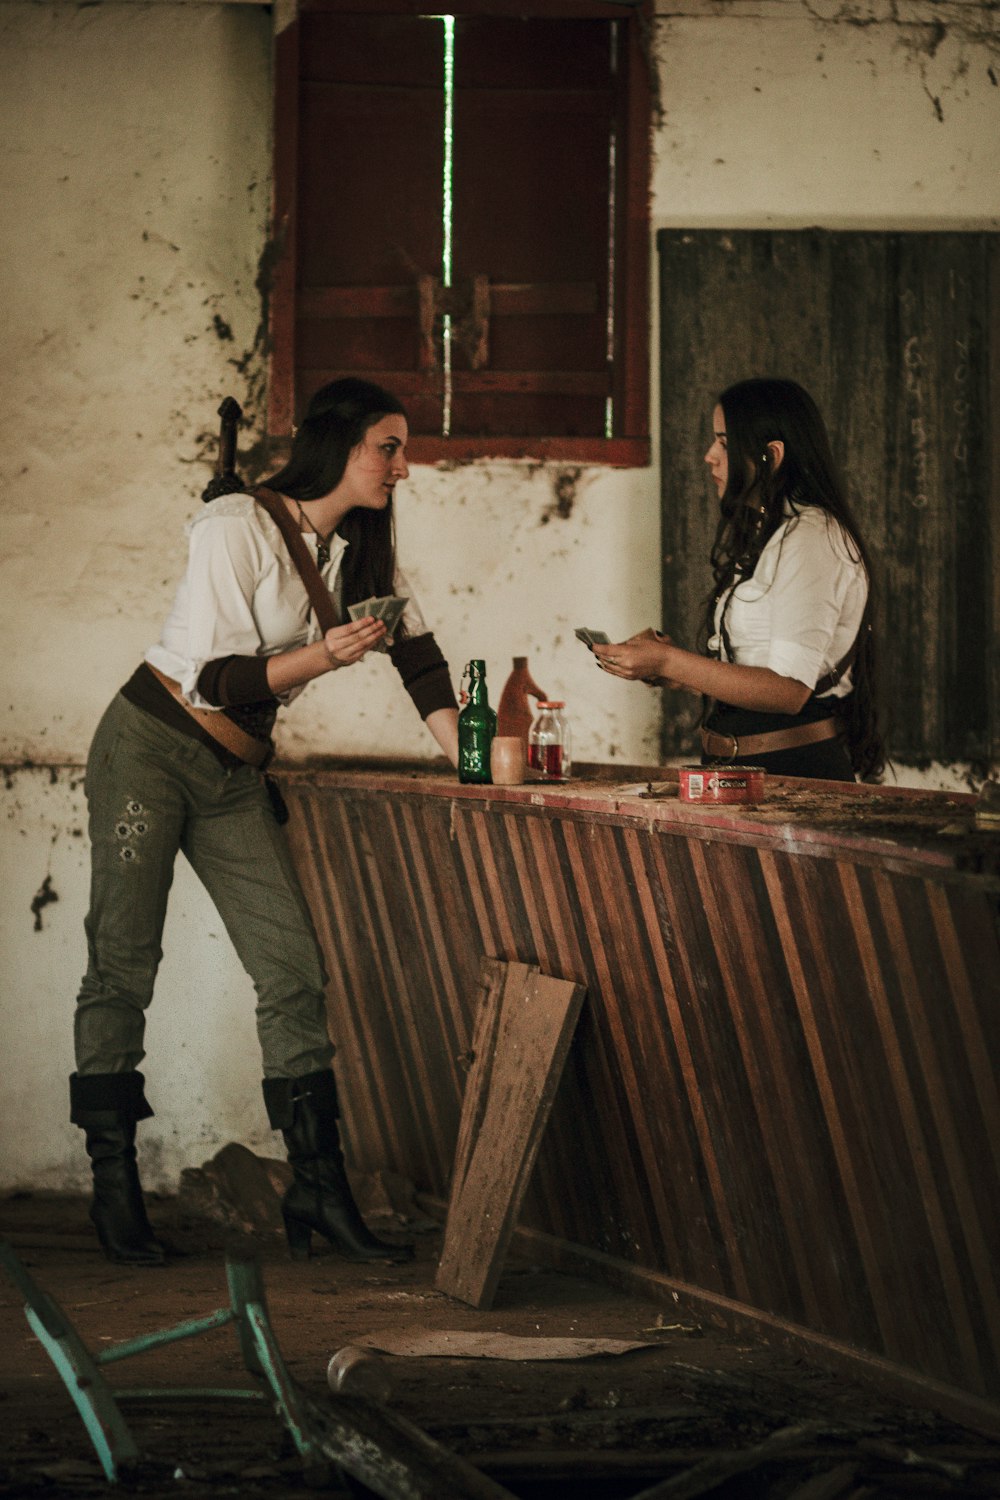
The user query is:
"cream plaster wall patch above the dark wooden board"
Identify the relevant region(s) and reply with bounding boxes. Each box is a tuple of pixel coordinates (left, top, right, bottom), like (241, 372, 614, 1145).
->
(654, 0, 1000, 230)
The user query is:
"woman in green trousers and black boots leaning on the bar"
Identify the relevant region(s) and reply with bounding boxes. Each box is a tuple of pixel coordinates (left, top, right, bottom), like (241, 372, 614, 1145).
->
(70, 380, 457, 1265)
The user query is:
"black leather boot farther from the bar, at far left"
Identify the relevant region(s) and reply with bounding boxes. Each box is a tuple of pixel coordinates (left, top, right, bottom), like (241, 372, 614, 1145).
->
(69, 1073, 166, 1266)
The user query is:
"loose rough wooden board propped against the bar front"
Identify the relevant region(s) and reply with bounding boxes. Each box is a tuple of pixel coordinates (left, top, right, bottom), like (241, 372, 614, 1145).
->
(435, 957, 586, 1308)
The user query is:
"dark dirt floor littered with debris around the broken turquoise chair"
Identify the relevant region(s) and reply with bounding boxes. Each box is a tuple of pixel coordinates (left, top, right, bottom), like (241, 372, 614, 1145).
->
(0, 1194, 1000, 1500)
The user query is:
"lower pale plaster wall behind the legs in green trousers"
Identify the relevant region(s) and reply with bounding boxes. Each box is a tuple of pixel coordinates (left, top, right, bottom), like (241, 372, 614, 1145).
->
(0, 767, 280, 1190)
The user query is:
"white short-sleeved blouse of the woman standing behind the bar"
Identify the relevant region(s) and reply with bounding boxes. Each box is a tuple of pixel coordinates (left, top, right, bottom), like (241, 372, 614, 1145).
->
(708, 506, 868, 698)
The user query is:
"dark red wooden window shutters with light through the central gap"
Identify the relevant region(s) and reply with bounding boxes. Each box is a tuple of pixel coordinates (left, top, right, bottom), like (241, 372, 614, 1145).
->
(268, 0, 649, 464)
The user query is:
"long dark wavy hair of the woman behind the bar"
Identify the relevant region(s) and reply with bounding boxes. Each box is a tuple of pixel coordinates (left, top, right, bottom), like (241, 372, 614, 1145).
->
(703, 378, 886, 777)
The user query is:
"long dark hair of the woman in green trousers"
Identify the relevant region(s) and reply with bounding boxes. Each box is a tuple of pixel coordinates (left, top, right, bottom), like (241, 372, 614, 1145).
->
(264, 378, 406, 627)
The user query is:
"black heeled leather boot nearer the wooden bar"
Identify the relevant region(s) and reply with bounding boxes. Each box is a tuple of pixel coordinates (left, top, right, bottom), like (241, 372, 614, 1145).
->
(264, 1071, 414, 1260)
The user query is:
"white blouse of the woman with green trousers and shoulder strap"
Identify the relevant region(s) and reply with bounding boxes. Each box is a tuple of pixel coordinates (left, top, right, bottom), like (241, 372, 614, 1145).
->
(145, 495, 427, 710)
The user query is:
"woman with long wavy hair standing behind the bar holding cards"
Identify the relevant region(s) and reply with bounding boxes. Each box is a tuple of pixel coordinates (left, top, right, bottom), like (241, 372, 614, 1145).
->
(594, 380, 885, 782)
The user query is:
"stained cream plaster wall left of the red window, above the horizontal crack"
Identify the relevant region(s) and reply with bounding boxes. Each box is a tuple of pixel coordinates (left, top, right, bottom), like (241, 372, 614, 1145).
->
(0, 5, 270, 761)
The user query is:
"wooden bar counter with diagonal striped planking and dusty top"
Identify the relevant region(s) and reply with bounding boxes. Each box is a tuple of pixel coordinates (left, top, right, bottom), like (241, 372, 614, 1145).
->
(280, 765, 1000, 1431)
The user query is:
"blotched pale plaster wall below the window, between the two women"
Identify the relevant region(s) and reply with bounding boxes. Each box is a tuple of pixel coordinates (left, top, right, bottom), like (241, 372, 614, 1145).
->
(282, 464, 660, 761)
